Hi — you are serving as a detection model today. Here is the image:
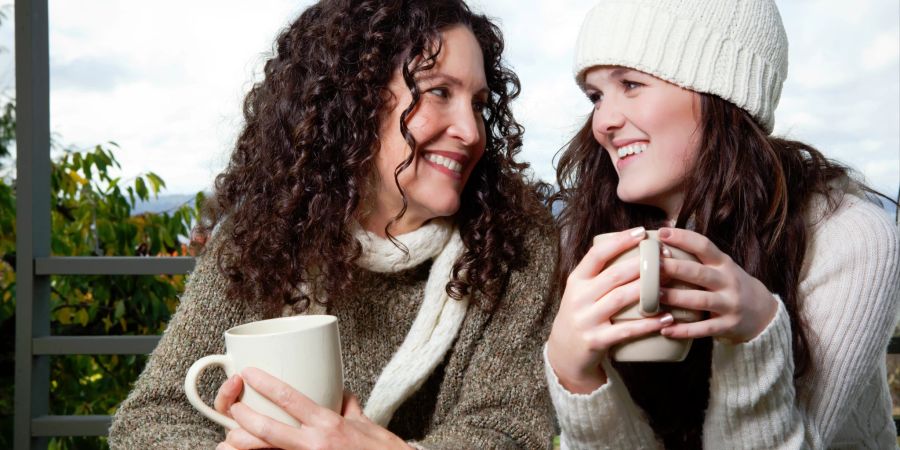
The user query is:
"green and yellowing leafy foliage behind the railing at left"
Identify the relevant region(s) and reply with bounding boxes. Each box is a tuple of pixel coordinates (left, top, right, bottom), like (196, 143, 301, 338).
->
(0, 97, 203, 449)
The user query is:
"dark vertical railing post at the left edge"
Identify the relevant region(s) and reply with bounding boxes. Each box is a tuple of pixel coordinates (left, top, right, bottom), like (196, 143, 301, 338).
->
(14, 0, 50, 450)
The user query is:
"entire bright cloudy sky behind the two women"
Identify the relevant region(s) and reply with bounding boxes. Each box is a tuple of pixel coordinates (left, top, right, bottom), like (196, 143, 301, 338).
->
(0, 0, 900, 200)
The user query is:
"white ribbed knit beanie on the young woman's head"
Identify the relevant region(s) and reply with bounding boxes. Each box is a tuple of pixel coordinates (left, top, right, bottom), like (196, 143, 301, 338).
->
(575, 0, 788, 133)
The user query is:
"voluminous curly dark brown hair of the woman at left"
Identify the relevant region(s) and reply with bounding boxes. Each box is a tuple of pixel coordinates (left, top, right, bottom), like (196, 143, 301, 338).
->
(198, 0, 546, 307)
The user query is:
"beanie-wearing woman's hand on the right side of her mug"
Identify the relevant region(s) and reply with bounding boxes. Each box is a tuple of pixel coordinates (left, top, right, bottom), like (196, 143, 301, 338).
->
(659, 228, 778, 343)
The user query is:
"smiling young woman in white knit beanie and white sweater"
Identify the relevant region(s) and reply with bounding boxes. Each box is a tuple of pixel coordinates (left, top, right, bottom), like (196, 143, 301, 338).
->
(545, 0, 900, 449)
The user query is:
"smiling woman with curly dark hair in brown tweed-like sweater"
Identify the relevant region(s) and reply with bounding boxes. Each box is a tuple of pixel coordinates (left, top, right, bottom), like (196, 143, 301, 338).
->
(110, 0, 556, 449)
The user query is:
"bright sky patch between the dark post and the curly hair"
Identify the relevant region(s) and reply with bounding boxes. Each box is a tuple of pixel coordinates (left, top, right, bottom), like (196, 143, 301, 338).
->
(41, 0, 309, 192)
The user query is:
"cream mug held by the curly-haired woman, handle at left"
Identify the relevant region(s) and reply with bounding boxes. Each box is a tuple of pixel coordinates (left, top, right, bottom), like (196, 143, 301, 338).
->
(184, 315, 344, 429)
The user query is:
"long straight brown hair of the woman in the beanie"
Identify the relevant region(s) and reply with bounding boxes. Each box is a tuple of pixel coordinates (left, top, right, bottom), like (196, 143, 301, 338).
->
(551, 94, 884, 448)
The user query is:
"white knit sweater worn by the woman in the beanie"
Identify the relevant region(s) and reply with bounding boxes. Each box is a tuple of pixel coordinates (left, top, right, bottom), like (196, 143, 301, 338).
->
(544, 195, 900, 449)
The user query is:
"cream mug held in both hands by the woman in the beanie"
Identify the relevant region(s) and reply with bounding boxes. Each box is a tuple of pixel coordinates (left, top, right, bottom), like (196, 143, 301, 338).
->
(594, 231, 702, 362)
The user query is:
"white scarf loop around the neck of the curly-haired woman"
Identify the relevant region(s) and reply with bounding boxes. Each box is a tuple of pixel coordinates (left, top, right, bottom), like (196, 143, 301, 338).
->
(353, 218, 453, 273)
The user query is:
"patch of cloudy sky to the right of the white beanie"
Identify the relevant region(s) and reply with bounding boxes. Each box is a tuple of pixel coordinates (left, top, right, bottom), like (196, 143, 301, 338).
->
(775, 0, 900, 195)
